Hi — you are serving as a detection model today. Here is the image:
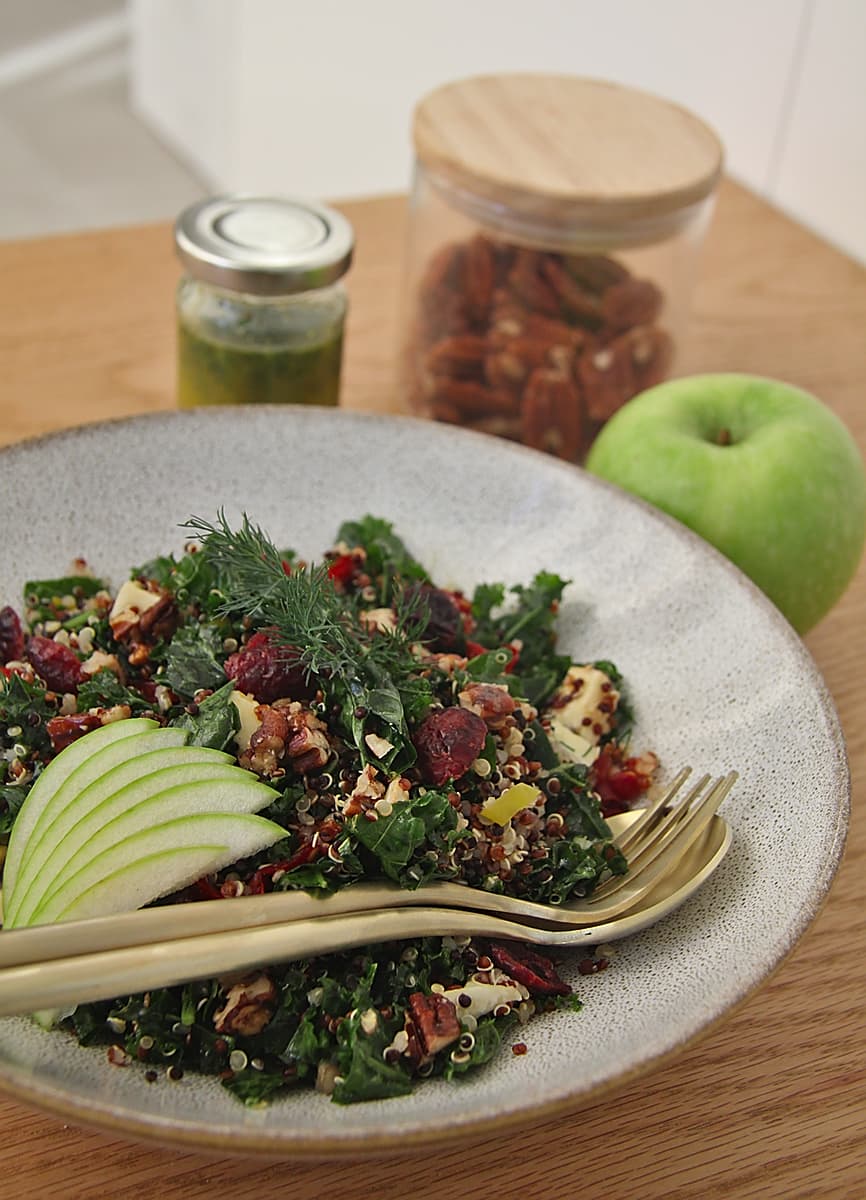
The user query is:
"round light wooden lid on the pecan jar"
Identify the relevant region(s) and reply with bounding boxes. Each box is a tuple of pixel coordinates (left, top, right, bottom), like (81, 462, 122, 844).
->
(413, 74, 723, 236)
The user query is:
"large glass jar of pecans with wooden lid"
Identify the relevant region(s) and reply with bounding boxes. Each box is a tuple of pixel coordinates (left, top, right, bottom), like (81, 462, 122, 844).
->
(402, 76, 722, 462)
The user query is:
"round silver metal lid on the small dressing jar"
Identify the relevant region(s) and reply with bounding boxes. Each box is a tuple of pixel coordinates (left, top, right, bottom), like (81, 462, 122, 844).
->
(174, 196, 355, 296)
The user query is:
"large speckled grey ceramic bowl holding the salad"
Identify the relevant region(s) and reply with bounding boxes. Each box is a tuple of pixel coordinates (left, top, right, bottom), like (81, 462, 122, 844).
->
(0, 409, 849, 1157)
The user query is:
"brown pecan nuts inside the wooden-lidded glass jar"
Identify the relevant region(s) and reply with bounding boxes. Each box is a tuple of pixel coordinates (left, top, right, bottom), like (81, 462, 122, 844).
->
(408, 233, 673, 461)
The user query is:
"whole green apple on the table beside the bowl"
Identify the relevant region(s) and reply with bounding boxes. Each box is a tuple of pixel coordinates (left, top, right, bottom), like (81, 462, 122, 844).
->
(587, 374, 866, 634)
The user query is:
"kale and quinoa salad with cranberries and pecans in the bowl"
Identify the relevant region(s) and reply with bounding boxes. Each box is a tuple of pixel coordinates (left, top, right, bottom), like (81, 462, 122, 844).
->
(0, 514, 657, 1105)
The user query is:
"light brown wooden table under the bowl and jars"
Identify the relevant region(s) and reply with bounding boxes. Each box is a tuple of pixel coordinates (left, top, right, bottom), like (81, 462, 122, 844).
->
(0, 184, 866, 1200)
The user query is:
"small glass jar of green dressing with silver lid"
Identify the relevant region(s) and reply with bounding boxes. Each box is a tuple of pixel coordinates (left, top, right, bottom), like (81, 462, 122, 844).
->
(175, 196, 354, 408)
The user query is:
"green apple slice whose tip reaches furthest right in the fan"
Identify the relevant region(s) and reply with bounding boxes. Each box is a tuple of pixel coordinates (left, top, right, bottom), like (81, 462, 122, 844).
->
(29, 812, 285, 925)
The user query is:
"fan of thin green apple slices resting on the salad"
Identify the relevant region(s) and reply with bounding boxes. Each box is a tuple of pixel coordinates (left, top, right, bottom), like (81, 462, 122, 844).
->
(4, 720, 285, 929)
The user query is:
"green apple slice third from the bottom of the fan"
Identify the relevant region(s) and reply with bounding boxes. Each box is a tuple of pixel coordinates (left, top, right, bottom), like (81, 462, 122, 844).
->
(11, 763, 269, 925)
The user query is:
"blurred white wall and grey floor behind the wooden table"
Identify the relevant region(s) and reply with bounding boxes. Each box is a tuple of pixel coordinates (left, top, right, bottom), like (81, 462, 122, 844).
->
(0, 0, 866, 262)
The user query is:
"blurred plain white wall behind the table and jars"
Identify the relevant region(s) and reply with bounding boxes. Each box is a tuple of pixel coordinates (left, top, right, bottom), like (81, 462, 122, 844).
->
(131, 0, 866, 260)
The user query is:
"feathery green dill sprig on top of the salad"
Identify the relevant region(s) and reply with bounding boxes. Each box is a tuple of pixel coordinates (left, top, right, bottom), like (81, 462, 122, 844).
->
(184, 510, 426, 766)
